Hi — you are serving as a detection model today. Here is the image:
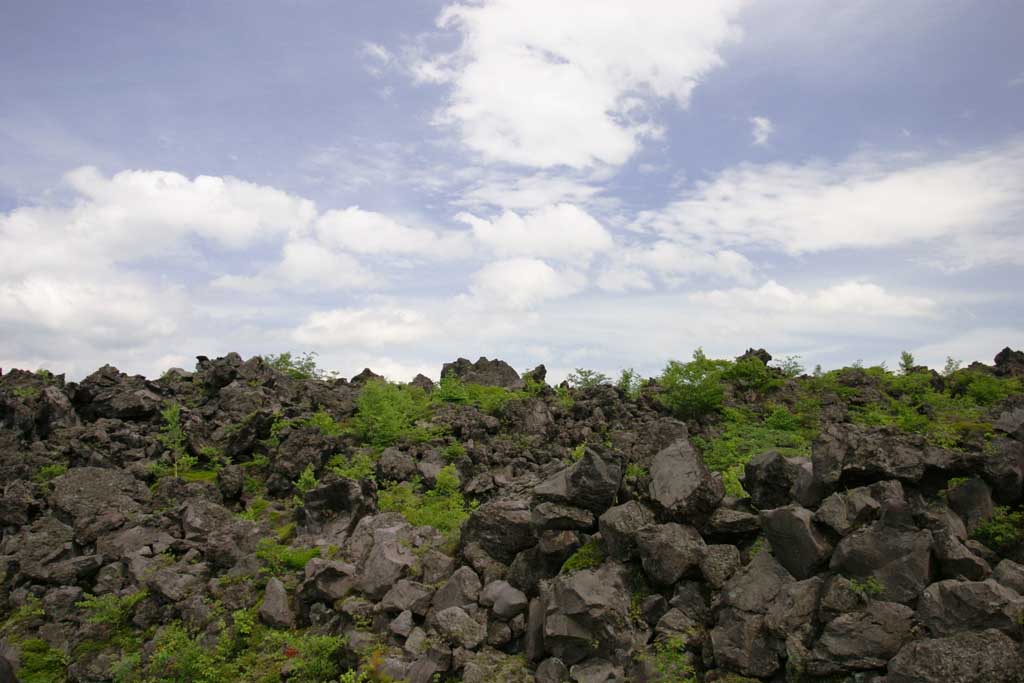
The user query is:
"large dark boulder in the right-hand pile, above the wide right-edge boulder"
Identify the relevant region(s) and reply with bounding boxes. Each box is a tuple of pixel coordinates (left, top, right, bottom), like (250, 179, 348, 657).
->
(829, 521, 932, 603)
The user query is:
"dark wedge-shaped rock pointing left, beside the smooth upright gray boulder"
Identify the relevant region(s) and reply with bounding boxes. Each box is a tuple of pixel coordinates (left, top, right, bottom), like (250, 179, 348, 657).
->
(534, 446, 623, 514)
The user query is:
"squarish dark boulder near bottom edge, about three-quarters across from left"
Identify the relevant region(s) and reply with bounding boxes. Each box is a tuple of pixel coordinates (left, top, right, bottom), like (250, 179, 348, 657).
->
(711, 608, 779, 678)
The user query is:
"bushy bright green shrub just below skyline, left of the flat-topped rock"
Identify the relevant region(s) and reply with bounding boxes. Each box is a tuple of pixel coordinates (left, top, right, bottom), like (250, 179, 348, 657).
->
(352, 380, 432, 449)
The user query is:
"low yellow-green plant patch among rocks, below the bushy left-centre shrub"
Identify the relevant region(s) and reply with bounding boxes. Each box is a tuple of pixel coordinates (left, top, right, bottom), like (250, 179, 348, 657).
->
(377, 465, 472, 542)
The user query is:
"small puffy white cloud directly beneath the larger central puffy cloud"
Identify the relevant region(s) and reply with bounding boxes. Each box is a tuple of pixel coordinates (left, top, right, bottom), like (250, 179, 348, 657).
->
(470, 258, 586, 309)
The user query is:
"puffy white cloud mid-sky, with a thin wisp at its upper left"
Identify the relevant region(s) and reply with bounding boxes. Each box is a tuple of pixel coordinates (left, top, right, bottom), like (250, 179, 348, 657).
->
(456, 204, 612, 263)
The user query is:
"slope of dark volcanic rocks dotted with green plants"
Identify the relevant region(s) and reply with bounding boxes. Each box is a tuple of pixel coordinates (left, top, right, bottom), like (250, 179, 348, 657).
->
(0, 349, 1024, 683)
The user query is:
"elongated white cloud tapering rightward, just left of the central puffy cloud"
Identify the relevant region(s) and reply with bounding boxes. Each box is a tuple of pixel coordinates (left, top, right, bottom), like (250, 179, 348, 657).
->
(315, 206, 469, 258)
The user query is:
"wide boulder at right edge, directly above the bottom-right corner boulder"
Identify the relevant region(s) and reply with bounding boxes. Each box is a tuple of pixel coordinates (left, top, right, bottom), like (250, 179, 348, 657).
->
(916, 579, 1024, 638)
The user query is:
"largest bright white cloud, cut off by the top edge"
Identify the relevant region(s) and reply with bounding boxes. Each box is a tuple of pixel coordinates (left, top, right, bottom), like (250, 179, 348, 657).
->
(415, 0, 742, 168)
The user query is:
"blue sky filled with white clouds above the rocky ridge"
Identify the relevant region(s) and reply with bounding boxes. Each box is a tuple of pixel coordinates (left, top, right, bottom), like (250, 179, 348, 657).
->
(0, 0, 1024, 381)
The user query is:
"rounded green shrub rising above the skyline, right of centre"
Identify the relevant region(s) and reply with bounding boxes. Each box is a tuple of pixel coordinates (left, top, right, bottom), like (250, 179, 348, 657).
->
(657, 349, 729, 420)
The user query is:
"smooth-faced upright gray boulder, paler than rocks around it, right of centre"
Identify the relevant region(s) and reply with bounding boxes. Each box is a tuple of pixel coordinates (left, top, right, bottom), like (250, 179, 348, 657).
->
(648, 437, 725, 519)
